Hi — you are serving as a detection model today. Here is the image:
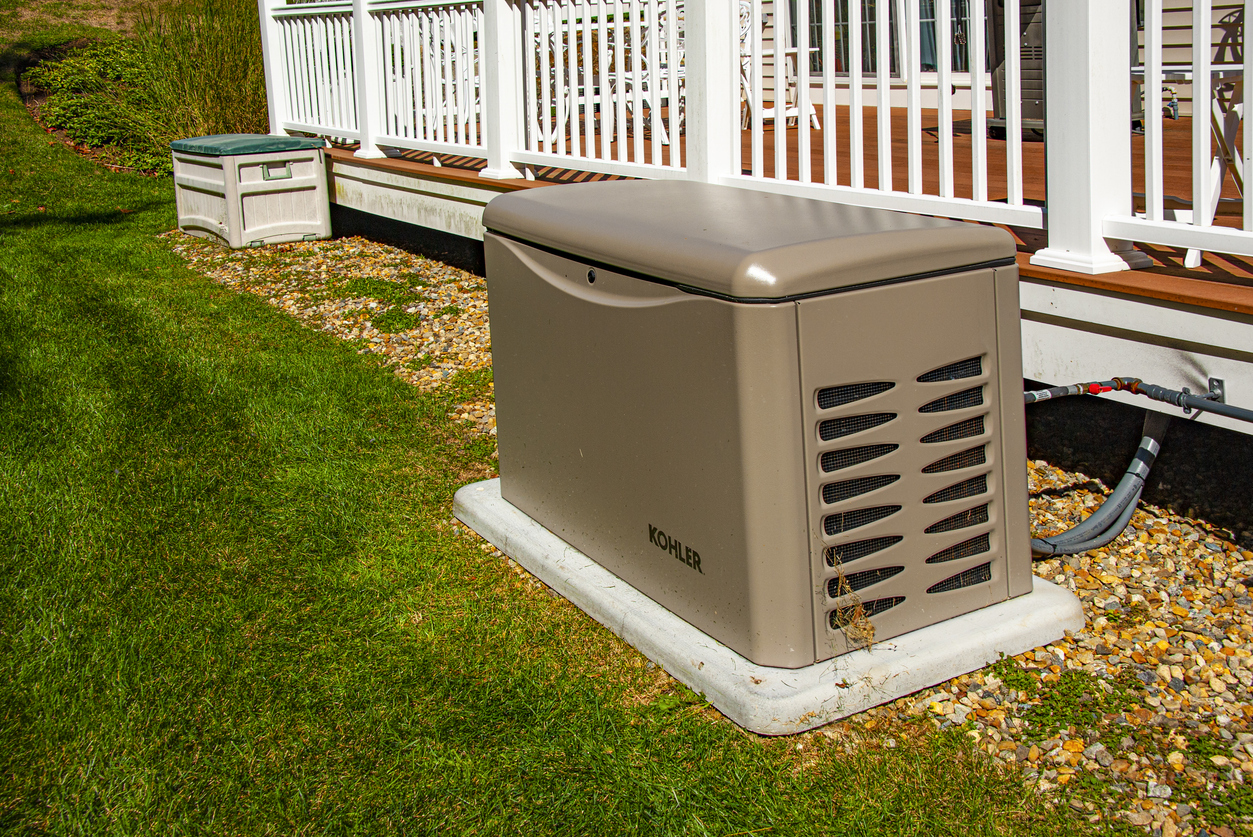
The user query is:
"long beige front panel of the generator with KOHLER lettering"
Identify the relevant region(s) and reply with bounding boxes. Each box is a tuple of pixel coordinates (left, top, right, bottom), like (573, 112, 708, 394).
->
(485, 233, 814, 668)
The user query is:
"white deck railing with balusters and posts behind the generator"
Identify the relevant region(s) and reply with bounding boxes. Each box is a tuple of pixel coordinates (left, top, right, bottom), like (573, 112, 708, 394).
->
(259, 0, 1253, 273)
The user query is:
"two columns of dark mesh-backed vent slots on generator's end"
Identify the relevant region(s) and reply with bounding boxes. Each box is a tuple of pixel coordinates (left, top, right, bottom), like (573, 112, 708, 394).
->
(809, 355, 996, 645)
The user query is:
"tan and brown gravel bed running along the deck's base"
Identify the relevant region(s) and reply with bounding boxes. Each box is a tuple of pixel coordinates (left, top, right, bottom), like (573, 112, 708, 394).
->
(167, 232, 1253, 837)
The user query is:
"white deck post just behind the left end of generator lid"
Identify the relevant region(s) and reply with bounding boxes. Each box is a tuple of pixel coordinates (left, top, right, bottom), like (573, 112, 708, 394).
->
(479, 0, 523, 180)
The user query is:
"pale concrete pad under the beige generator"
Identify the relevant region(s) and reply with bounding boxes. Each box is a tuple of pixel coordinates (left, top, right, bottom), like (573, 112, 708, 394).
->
(452, 480, 1084, 736)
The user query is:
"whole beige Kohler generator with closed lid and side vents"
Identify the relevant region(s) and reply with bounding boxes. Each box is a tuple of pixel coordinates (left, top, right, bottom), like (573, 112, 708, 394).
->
(484, 180, 1031, 668)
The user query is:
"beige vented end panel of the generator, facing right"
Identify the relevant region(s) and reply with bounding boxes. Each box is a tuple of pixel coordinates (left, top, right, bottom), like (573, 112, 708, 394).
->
(798, 269, 1021, 658)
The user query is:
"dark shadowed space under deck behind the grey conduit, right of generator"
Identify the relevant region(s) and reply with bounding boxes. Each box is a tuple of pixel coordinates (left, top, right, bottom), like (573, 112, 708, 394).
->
(1025, 381, 1253, 549)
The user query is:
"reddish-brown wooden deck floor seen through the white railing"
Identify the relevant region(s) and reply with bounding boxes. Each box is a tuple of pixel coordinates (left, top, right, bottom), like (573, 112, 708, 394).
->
(331, 108, 1253, 316)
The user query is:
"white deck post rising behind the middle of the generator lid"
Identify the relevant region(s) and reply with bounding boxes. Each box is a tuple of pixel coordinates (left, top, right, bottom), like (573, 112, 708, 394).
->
(670, 0, 739, 183)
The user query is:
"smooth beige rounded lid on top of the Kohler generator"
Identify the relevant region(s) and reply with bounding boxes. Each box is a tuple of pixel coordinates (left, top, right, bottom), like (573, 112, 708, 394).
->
(484, 180, 1015, 299)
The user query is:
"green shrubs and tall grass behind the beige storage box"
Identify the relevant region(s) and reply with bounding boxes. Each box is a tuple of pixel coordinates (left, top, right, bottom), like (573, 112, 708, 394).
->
(26, 0, 268, 173)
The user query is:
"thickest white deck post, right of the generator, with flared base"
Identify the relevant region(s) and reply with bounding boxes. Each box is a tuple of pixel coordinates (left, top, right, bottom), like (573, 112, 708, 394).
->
(1031, 0, 1152, 273)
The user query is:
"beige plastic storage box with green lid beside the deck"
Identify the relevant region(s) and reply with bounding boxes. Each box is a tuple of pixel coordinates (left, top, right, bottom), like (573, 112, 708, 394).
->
(170, 134, 331, 247)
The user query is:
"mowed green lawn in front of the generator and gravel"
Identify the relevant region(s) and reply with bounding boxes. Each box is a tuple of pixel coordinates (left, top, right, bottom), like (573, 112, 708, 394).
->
(0, 31, 1091, 834)
